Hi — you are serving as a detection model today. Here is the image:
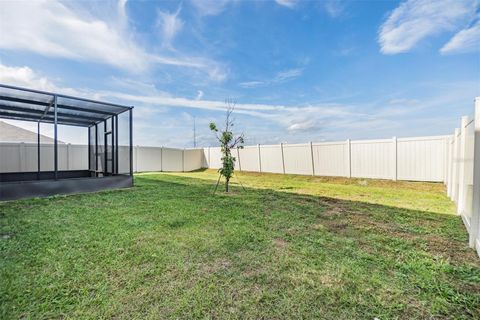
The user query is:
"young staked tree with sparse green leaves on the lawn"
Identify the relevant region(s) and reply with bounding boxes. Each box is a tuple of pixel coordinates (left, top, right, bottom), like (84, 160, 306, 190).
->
(210, 100, 244, 192)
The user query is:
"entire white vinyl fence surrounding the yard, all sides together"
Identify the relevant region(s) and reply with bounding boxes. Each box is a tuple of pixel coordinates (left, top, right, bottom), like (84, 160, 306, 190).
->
(0, 98, 480, 255)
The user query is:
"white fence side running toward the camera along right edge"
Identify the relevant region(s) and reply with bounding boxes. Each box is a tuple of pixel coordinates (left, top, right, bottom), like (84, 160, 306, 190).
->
(446, 98, 480, 255)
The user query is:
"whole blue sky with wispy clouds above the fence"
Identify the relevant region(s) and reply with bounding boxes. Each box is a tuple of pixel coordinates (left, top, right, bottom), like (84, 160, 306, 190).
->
(0, 0, 480, 148)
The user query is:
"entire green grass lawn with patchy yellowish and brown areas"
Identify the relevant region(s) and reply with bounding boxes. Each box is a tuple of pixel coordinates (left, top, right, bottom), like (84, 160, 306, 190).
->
(0, 170, 480, 319)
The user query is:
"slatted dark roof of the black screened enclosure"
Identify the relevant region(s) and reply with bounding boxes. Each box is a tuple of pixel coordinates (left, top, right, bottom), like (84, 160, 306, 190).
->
(0, 84, 133, 127)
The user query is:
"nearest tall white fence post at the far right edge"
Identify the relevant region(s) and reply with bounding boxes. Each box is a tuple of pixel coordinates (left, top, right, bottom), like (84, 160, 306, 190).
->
(469, 97, 480, 250)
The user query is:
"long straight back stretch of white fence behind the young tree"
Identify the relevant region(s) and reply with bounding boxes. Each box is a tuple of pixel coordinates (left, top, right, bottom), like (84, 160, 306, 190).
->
(204, 136, 451, 182)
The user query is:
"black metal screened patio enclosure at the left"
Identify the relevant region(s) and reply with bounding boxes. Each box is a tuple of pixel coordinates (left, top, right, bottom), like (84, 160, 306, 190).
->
(0, 84, 133, 200)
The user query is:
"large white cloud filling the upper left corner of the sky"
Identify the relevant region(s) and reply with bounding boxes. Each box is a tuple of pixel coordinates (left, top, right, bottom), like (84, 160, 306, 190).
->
(0, 1, 146, 70)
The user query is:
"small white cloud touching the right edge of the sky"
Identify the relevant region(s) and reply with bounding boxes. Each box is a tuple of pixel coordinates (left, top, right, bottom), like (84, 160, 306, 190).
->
(440, 22, 480, 54)
